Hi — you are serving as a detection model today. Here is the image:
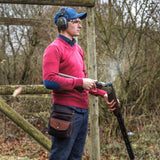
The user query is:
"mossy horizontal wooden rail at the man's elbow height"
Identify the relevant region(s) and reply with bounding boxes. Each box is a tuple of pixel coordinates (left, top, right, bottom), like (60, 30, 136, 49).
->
(0, 85, 52, 95)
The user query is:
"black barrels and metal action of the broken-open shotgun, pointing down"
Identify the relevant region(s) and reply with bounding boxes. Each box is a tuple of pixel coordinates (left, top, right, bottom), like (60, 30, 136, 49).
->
(96, 82, 134, 160)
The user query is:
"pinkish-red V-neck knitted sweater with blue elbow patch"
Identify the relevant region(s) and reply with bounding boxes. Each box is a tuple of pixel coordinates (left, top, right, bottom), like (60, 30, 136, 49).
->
(43, 36, 106, 109)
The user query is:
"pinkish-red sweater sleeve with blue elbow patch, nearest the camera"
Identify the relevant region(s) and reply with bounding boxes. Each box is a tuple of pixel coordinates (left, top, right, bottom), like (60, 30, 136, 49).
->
(43, 45, 83, 90)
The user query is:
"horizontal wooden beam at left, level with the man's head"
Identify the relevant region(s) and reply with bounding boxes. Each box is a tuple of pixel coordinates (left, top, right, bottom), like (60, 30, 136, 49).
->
(0, 17, 50, 26)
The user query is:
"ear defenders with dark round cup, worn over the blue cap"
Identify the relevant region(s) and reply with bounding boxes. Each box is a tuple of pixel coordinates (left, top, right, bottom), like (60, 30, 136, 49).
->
(57, 7, 68, 31)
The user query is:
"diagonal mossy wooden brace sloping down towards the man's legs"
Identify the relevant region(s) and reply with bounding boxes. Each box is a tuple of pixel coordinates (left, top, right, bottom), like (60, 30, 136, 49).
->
(0, 97, 51, 151)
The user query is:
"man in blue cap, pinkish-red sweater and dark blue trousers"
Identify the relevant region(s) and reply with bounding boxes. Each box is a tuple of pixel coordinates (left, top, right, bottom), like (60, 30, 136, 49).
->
(43, 7, 115, 160)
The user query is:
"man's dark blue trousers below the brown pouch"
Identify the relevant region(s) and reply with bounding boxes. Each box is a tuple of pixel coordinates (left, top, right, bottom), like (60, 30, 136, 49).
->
(49, 105, 88, 160)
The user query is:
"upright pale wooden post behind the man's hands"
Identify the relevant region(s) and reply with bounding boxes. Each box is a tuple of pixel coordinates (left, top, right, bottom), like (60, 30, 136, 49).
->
(87, 8, 100, 160)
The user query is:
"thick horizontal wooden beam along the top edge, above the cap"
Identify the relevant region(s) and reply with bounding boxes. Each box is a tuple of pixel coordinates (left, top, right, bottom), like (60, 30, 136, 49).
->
(0, 0, 95, 7)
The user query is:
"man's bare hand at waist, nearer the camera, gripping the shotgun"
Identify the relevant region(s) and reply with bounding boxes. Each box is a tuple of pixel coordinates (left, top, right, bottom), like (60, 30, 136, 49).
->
(82, 78, 96, 91)
